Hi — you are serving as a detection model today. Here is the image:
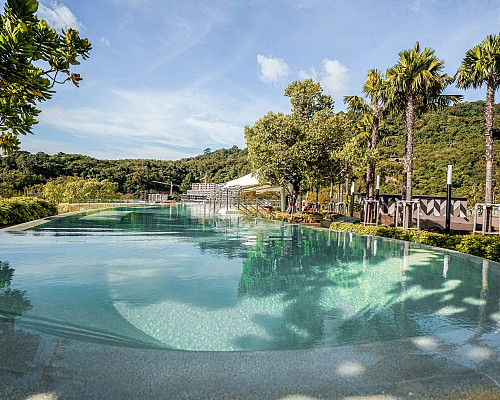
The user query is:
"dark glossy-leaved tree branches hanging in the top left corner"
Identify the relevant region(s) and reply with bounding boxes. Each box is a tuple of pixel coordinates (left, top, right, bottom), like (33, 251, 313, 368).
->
(0, 0, 91, 154)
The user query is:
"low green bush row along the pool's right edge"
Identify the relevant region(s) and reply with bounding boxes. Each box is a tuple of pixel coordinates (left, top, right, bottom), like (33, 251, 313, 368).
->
(330, 222, 500, 261)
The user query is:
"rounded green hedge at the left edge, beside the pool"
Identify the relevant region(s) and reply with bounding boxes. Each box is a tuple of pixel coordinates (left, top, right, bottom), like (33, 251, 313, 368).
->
(0, 197, 57, 226)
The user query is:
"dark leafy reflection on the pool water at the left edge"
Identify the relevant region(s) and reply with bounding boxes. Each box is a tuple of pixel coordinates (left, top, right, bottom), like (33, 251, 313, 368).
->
(0, 261, 32, 334)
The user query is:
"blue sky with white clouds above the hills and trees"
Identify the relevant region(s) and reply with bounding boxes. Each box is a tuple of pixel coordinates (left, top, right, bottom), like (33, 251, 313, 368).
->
(0, 0, 500, 160)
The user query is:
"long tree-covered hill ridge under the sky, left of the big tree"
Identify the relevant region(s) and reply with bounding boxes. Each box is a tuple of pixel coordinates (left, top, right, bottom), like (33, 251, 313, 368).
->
(0, 146, 250, 198)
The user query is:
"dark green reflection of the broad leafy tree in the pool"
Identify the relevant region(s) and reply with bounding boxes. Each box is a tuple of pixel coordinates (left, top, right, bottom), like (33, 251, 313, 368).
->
(235, 225, 376, 348)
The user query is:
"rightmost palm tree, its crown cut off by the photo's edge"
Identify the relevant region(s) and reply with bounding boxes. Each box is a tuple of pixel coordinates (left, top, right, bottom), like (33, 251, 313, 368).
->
(455, 35, 500, 219)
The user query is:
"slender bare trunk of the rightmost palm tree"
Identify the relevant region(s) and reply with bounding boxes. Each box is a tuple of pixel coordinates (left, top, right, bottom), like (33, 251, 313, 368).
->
(484, 82, 495, 231)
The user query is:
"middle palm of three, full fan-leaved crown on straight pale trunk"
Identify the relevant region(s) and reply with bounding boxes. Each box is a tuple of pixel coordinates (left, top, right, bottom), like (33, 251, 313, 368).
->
(385, 42, 462, 226)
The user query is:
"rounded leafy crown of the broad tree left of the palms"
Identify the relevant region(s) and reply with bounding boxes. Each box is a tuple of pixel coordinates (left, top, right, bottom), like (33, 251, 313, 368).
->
(245, 79, 349, 202)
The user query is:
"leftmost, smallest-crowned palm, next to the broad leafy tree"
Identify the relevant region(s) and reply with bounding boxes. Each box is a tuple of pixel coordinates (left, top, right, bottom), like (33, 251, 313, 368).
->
(344, 69, 386, 200)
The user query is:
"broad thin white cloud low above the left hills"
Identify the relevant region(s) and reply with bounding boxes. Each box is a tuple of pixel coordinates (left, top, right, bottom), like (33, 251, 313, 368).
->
(36, 89, 254, 159)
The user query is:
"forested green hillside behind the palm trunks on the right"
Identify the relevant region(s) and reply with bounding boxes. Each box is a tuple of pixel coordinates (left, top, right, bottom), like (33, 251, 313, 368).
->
(379, 101, 500, 203)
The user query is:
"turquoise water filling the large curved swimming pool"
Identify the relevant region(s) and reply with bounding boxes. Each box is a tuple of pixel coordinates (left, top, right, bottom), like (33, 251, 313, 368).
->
(0, 206, 500, 351)
